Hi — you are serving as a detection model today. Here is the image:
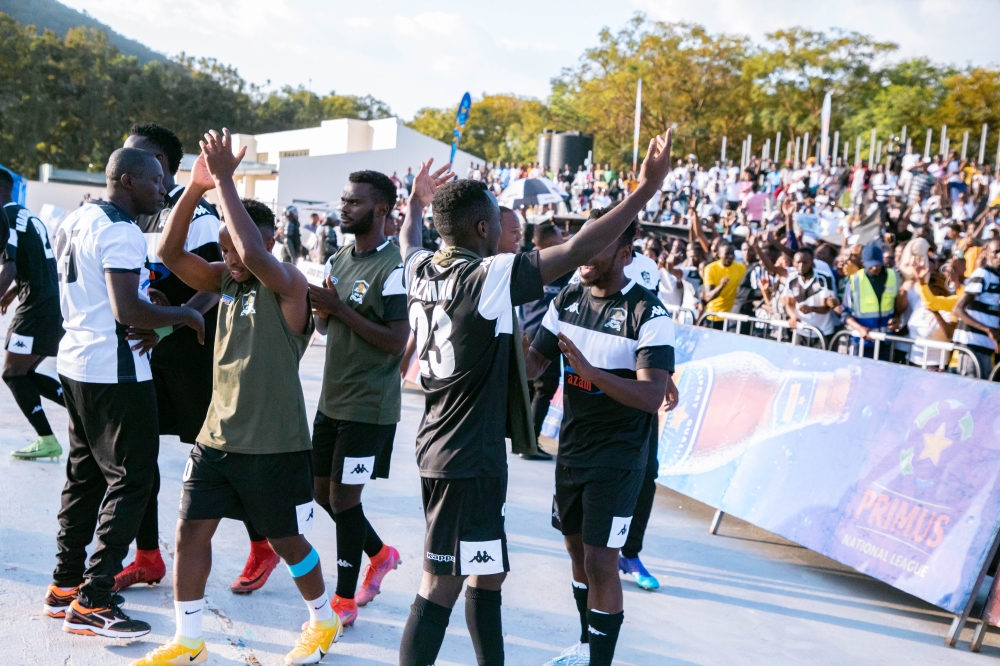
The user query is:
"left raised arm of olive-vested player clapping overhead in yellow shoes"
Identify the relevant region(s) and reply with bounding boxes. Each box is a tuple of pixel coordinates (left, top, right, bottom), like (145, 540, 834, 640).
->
(158, 156, 226, 294)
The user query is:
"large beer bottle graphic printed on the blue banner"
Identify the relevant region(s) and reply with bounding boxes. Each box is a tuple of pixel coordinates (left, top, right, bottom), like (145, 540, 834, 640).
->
(660, 351, 858, 476)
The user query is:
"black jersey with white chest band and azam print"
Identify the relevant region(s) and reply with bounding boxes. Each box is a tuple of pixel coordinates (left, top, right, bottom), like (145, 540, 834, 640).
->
(532, 281, 674, 469)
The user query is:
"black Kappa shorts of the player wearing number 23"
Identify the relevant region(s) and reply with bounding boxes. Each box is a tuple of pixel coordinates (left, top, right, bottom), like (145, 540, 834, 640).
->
(420, 475, 510, 576)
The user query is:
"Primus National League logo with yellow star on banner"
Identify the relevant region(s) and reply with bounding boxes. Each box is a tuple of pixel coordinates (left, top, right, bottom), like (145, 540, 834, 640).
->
(834, 400, 994, 581)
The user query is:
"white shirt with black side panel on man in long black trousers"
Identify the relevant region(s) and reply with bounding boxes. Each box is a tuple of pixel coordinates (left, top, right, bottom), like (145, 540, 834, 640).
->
(56, 201, 153, 384)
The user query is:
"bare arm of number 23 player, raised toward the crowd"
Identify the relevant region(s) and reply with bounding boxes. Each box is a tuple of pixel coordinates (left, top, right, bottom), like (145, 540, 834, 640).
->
(538, 129, 673, 284)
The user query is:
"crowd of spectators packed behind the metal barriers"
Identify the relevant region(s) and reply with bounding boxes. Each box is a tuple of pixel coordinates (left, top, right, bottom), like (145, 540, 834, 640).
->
(270, 141, 1000, 376)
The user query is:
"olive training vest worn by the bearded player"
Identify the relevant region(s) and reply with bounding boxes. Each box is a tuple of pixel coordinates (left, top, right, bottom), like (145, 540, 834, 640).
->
(319, 241, 406, 425)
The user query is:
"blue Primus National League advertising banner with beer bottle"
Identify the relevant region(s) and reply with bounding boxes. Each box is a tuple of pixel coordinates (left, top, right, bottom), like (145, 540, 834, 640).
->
(658, 326, 1000, 613)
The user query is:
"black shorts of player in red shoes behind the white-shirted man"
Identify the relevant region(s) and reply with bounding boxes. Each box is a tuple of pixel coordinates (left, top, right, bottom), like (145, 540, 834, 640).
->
(151, 365, 212, 444)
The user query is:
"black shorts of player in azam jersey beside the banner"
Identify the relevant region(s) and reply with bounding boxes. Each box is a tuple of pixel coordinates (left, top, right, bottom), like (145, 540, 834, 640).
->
(552, 464, 646, 548)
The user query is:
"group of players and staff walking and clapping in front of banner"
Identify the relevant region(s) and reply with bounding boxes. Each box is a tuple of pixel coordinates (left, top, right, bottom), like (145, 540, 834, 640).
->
(0, 124, 677, 666)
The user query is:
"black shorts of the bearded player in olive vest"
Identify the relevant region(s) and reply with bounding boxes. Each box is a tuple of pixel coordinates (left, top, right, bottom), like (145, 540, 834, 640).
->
(312, 411, 396, 485)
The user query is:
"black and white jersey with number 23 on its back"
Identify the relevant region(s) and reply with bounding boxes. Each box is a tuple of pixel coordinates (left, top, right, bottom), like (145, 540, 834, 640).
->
(404, 250, 543, 479)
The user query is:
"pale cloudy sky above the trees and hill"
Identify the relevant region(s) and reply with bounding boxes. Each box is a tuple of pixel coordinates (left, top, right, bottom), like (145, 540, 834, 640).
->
(62, 0, 1000, 119)
